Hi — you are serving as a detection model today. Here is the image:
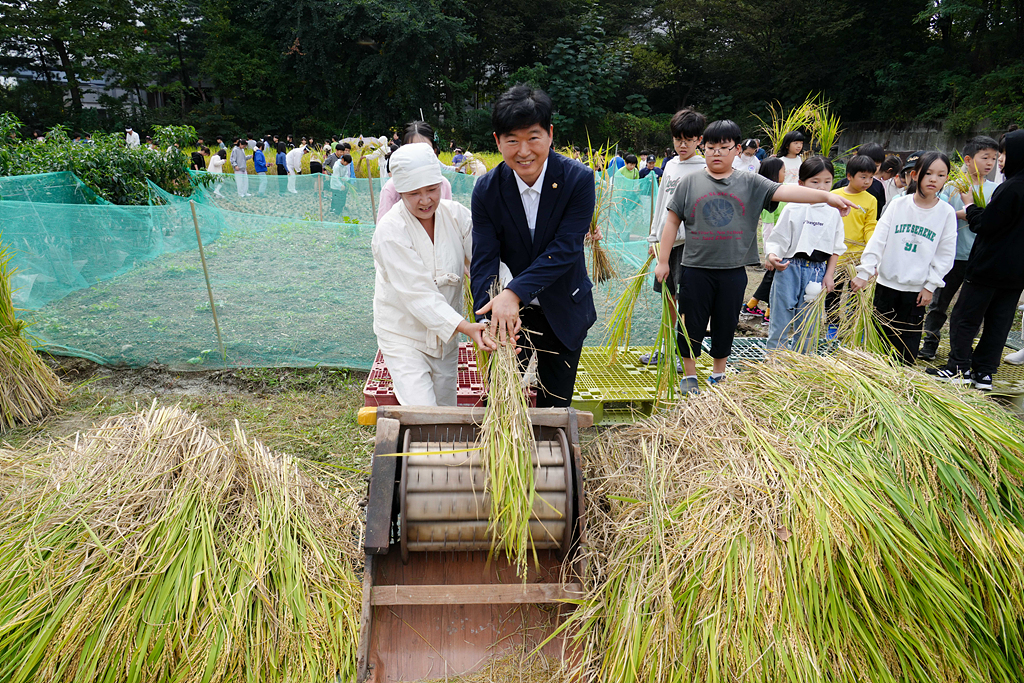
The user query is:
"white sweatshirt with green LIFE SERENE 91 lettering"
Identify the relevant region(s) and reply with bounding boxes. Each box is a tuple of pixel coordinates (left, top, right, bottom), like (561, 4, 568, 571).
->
(857, 195, 956, 292)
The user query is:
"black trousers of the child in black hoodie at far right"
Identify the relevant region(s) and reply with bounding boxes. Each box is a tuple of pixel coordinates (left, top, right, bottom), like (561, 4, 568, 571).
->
(946, 282, 1024, 376)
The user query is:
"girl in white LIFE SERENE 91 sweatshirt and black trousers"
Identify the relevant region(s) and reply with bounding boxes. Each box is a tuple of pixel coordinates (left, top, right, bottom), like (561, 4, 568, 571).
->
(851, 152, 956, 366)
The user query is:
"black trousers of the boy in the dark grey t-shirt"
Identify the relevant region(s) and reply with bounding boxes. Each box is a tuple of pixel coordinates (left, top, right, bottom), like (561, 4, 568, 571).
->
(678, 266, 746, 358)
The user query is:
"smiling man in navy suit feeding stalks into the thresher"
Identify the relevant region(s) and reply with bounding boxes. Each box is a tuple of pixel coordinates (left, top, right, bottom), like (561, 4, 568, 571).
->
(470, 85, 597, 407)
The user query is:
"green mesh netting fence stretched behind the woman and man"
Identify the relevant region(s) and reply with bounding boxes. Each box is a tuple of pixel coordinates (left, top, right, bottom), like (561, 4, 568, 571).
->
(0, 174, 660, 370)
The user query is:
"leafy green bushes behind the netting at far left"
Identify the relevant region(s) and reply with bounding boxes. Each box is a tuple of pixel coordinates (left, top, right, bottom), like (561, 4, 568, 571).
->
(0, 113, 196, 205)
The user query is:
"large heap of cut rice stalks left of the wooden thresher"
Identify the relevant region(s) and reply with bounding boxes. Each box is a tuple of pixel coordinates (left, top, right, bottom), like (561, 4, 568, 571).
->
(0, 407, 361, 683)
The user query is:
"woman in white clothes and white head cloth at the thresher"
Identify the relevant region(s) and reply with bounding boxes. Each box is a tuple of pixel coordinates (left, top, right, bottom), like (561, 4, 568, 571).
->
(373, 143, 497, 405)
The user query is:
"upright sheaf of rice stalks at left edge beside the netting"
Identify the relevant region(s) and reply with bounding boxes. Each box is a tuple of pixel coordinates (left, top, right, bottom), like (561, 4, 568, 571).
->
(0, 242, 65, 431)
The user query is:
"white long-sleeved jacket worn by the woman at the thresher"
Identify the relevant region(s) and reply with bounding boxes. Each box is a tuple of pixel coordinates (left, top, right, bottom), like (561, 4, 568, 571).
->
(371, 200, 473, 357)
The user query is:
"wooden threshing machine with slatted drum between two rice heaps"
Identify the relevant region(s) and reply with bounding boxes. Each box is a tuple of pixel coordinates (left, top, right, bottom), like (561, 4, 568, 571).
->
(358, 405, 593, 683)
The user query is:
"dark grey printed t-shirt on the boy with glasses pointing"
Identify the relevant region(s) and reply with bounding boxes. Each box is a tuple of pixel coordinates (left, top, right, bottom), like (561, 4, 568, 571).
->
(669, 171, 781, 269)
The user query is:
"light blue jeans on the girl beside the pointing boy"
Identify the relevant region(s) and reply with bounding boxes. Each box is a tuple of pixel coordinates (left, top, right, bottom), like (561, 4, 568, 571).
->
(768, 258, 828, 353)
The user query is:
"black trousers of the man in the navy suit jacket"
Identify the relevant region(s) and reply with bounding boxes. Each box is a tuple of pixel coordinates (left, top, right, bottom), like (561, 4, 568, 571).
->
(519, 306, 583, 408)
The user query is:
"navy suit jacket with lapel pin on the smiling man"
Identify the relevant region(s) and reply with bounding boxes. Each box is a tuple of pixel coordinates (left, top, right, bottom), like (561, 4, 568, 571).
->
(470, 152, 597, 351)
